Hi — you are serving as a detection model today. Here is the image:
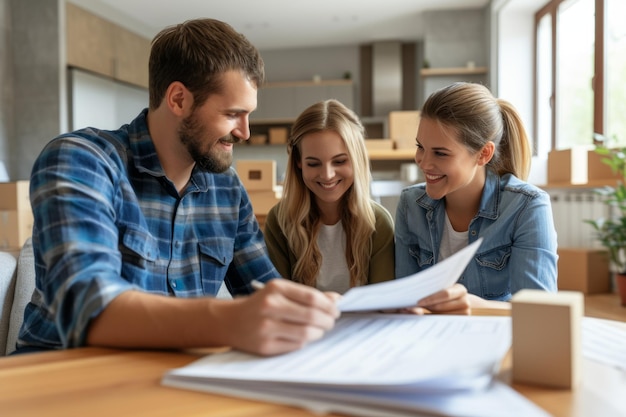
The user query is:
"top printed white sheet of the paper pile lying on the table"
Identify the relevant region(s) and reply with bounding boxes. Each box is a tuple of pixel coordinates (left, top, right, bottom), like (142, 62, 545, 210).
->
(162, 314, 511, 390)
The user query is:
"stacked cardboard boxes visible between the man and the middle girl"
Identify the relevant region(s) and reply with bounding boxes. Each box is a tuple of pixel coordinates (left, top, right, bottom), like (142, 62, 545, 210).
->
(235, 159, 282, 227)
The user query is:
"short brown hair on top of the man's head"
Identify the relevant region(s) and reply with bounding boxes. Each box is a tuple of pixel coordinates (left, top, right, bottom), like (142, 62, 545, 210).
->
(149, 19, 265, 109)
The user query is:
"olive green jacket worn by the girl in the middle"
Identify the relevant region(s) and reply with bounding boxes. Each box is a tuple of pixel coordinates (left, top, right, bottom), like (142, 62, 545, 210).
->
(264, 201, 395, 284)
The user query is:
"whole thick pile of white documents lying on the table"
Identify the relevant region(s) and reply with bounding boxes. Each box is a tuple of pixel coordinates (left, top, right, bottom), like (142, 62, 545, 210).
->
(162, 313, 546, 417)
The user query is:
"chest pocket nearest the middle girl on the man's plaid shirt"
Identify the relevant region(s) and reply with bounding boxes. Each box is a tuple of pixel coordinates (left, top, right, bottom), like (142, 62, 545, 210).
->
(198, 238, 234, 295)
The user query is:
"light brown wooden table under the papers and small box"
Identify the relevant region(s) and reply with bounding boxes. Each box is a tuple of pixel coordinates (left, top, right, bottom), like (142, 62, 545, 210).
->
(0, 295, 626, 417)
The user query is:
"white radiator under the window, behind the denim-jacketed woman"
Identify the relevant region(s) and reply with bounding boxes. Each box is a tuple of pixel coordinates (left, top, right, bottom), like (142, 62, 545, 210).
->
(548, 189, 610, 248)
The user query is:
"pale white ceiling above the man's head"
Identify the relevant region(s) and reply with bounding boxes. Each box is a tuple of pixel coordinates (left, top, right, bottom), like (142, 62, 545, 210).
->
(68, 0, 489, 50)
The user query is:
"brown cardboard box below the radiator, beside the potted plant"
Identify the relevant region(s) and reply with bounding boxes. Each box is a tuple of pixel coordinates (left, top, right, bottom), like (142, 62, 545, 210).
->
(557, 248, 611, 294)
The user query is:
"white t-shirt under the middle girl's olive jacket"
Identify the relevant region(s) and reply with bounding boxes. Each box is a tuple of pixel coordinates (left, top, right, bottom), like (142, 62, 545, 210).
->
(317, 221, 350, 294)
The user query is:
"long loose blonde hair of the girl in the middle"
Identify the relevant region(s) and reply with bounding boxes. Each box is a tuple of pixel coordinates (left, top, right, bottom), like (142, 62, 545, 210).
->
(277, 100, 376, 287)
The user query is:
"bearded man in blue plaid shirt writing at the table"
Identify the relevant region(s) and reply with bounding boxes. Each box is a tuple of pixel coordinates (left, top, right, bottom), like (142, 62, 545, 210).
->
(17, 19, 339, 355)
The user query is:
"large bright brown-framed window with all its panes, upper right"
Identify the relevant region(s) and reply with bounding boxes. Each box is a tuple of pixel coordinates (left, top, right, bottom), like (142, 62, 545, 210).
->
(535, 0, 626, 153)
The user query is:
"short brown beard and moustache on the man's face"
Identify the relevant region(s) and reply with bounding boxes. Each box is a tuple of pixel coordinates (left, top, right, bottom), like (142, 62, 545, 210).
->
(178, 111, 241, 173)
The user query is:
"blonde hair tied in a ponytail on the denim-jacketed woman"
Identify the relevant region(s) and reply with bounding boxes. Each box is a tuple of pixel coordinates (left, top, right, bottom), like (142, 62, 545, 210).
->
(421, 82, 532, 180)
